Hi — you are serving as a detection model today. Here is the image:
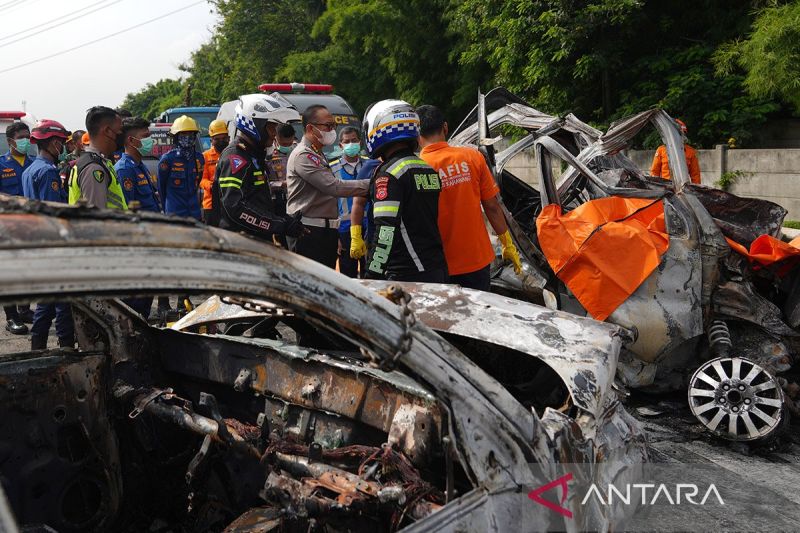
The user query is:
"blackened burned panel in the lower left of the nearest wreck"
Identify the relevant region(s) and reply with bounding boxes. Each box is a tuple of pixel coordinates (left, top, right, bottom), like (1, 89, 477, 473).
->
(0, 352, 122, 532)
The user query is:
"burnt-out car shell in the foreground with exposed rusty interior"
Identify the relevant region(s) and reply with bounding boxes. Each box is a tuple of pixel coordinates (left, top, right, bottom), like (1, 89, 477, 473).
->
(0, 197, 647, 532)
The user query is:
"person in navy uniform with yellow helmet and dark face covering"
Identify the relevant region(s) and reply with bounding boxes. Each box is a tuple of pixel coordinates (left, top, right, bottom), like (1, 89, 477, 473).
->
(158, 115, 204, 220)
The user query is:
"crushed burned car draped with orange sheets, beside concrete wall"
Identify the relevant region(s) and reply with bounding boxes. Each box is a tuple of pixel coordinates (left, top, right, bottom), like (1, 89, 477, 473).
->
(451, 88, 800, 441)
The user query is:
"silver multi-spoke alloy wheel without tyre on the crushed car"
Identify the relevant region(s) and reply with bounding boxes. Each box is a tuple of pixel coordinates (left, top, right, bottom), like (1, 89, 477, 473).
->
(689, 357, 783, 441)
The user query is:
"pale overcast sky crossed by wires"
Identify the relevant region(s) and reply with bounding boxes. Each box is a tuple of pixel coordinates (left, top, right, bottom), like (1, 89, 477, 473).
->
(0, 0, 217, 130)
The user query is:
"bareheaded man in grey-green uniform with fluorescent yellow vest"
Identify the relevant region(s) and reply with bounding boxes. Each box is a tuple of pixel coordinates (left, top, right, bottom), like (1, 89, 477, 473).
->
(67, 106, 128, 210)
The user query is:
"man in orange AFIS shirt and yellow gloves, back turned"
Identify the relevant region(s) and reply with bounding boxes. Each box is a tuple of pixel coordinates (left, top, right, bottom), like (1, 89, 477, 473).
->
(417, 105, 522, 291)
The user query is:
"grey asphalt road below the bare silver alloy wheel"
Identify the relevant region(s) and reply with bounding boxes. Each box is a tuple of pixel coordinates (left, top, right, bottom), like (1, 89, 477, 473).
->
(625, 393, 800, 532)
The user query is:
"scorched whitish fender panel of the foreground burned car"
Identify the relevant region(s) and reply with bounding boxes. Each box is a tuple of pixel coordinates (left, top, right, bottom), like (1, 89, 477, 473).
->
(362, 281, 626, 415)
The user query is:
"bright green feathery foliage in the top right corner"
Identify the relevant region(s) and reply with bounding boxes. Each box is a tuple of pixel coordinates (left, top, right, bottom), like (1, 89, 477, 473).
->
(714, 0, 800, 112)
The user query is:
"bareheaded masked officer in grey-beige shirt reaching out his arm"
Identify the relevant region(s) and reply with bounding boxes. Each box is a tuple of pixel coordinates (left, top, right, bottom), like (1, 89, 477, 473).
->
(286, 105, 369, 268)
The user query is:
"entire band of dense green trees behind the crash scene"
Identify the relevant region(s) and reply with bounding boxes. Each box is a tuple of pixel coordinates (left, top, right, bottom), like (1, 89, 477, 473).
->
(124, 0, 800, 146)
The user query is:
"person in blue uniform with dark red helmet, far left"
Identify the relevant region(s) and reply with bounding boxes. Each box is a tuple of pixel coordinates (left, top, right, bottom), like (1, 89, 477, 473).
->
(22, 120, 75, 350)
